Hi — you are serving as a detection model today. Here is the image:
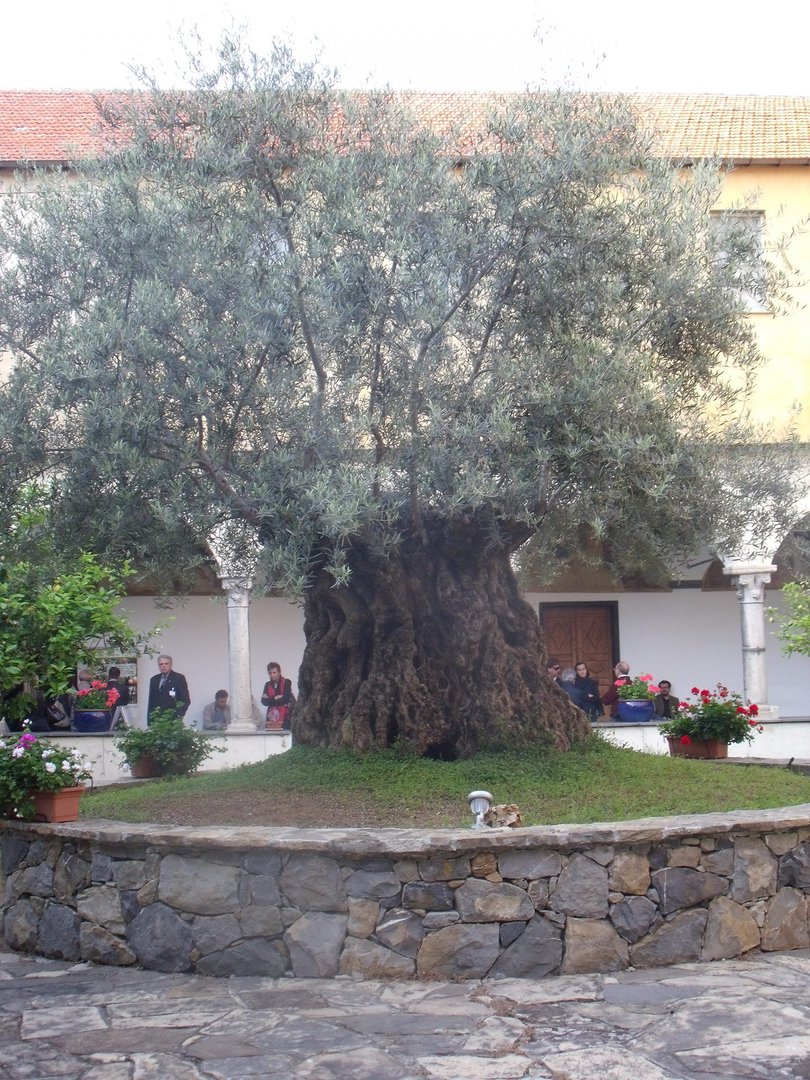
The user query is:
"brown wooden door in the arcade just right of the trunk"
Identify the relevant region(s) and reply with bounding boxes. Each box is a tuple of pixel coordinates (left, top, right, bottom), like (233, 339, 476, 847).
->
(540, 602, 619, 693)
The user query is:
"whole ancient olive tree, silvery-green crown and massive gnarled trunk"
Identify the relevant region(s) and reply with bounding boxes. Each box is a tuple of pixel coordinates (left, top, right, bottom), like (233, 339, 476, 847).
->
(0, 39, 799, 755)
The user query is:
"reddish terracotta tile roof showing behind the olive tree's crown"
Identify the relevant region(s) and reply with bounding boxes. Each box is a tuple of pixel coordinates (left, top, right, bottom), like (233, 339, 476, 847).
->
(0, 90, 810, 166)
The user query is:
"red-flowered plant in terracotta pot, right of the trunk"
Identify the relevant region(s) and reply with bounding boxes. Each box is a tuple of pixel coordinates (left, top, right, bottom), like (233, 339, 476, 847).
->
(659, 683, 762, 758)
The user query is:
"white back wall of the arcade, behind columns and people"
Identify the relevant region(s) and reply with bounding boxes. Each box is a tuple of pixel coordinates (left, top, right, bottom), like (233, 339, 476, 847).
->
(122, 589, 810, 725)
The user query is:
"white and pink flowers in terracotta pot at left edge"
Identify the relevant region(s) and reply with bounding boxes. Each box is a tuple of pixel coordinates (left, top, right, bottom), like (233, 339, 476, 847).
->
(0, 731, 93, 821)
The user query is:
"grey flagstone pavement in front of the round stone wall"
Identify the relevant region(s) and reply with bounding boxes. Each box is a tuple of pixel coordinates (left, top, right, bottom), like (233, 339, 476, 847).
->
(0, 950, 810, 1080)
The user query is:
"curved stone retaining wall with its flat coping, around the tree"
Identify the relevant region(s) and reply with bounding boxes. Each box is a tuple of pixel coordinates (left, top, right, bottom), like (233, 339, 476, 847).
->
(0, 805, 810, 978)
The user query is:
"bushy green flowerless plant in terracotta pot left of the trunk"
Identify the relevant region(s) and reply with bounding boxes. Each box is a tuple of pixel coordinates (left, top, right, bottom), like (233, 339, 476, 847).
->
(116, 708, 225, 779)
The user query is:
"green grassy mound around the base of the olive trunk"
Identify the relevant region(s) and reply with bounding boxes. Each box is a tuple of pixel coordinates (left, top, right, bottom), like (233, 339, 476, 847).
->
(82, 734, 810, 827)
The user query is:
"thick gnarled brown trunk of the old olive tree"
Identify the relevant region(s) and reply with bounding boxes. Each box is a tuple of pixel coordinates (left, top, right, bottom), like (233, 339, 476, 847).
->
(293, 523, 589, 759)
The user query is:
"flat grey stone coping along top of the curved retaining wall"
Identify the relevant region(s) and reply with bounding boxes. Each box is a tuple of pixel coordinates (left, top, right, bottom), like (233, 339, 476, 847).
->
(9, 802, 810, 858)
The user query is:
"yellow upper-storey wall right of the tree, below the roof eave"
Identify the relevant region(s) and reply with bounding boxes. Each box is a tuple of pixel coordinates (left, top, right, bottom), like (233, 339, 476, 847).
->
(717, 165, 810, 442)
